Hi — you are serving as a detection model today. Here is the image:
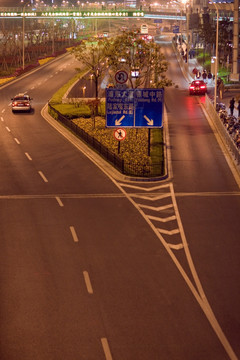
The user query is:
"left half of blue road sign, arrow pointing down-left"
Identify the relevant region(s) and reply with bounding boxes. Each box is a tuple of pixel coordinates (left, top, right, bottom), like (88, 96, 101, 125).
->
(106, 88, 134, 127)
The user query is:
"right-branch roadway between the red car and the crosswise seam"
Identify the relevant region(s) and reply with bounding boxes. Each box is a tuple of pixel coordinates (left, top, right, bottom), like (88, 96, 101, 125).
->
(165, 89, 238, 192)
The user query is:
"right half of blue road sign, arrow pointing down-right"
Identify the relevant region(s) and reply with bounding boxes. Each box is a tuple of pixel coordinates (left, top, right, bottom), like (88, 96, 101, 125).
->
(135, 89, 164, 128)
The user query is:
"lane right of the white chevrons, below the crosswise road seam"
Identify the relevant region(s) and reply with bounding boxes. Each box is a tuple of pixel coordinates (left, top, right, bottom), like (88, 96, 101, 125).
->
(176, 191, 240, 357)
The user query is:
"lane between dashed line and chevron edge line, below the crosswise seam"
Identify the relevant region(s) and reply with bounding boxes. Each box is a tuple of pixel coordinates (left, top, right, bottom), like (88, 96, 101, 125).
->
(64, 198, 232, 360)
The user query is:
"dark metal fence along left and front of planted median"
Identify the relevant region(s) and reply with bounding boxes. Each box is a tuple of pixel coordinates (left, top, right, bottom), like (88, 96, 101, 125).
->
(48, 103, 164, 178)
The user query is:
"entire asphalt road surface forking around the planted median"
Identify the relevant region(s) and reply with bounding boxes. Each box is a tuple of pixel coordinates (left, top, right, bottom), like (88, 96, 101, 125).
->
(0, 42, 240, 360)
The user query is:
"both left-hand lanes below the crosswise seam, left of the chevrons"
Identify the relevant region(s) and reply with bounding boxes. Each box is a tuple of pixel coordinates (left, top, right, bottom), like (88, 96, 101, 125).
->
(0, 196, 232, 360)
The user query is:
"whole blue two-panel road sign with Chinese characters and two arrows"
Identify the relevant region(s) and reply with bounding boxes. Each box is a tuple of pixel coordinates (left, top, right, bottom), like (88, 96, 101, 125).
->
(106, 88, 164, 128)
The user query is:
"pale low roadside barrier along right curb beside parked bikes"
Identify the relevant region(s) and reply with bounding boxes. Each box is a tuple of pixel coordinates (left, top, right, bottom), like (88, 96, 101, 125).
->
(205, 95, 240, 165)
